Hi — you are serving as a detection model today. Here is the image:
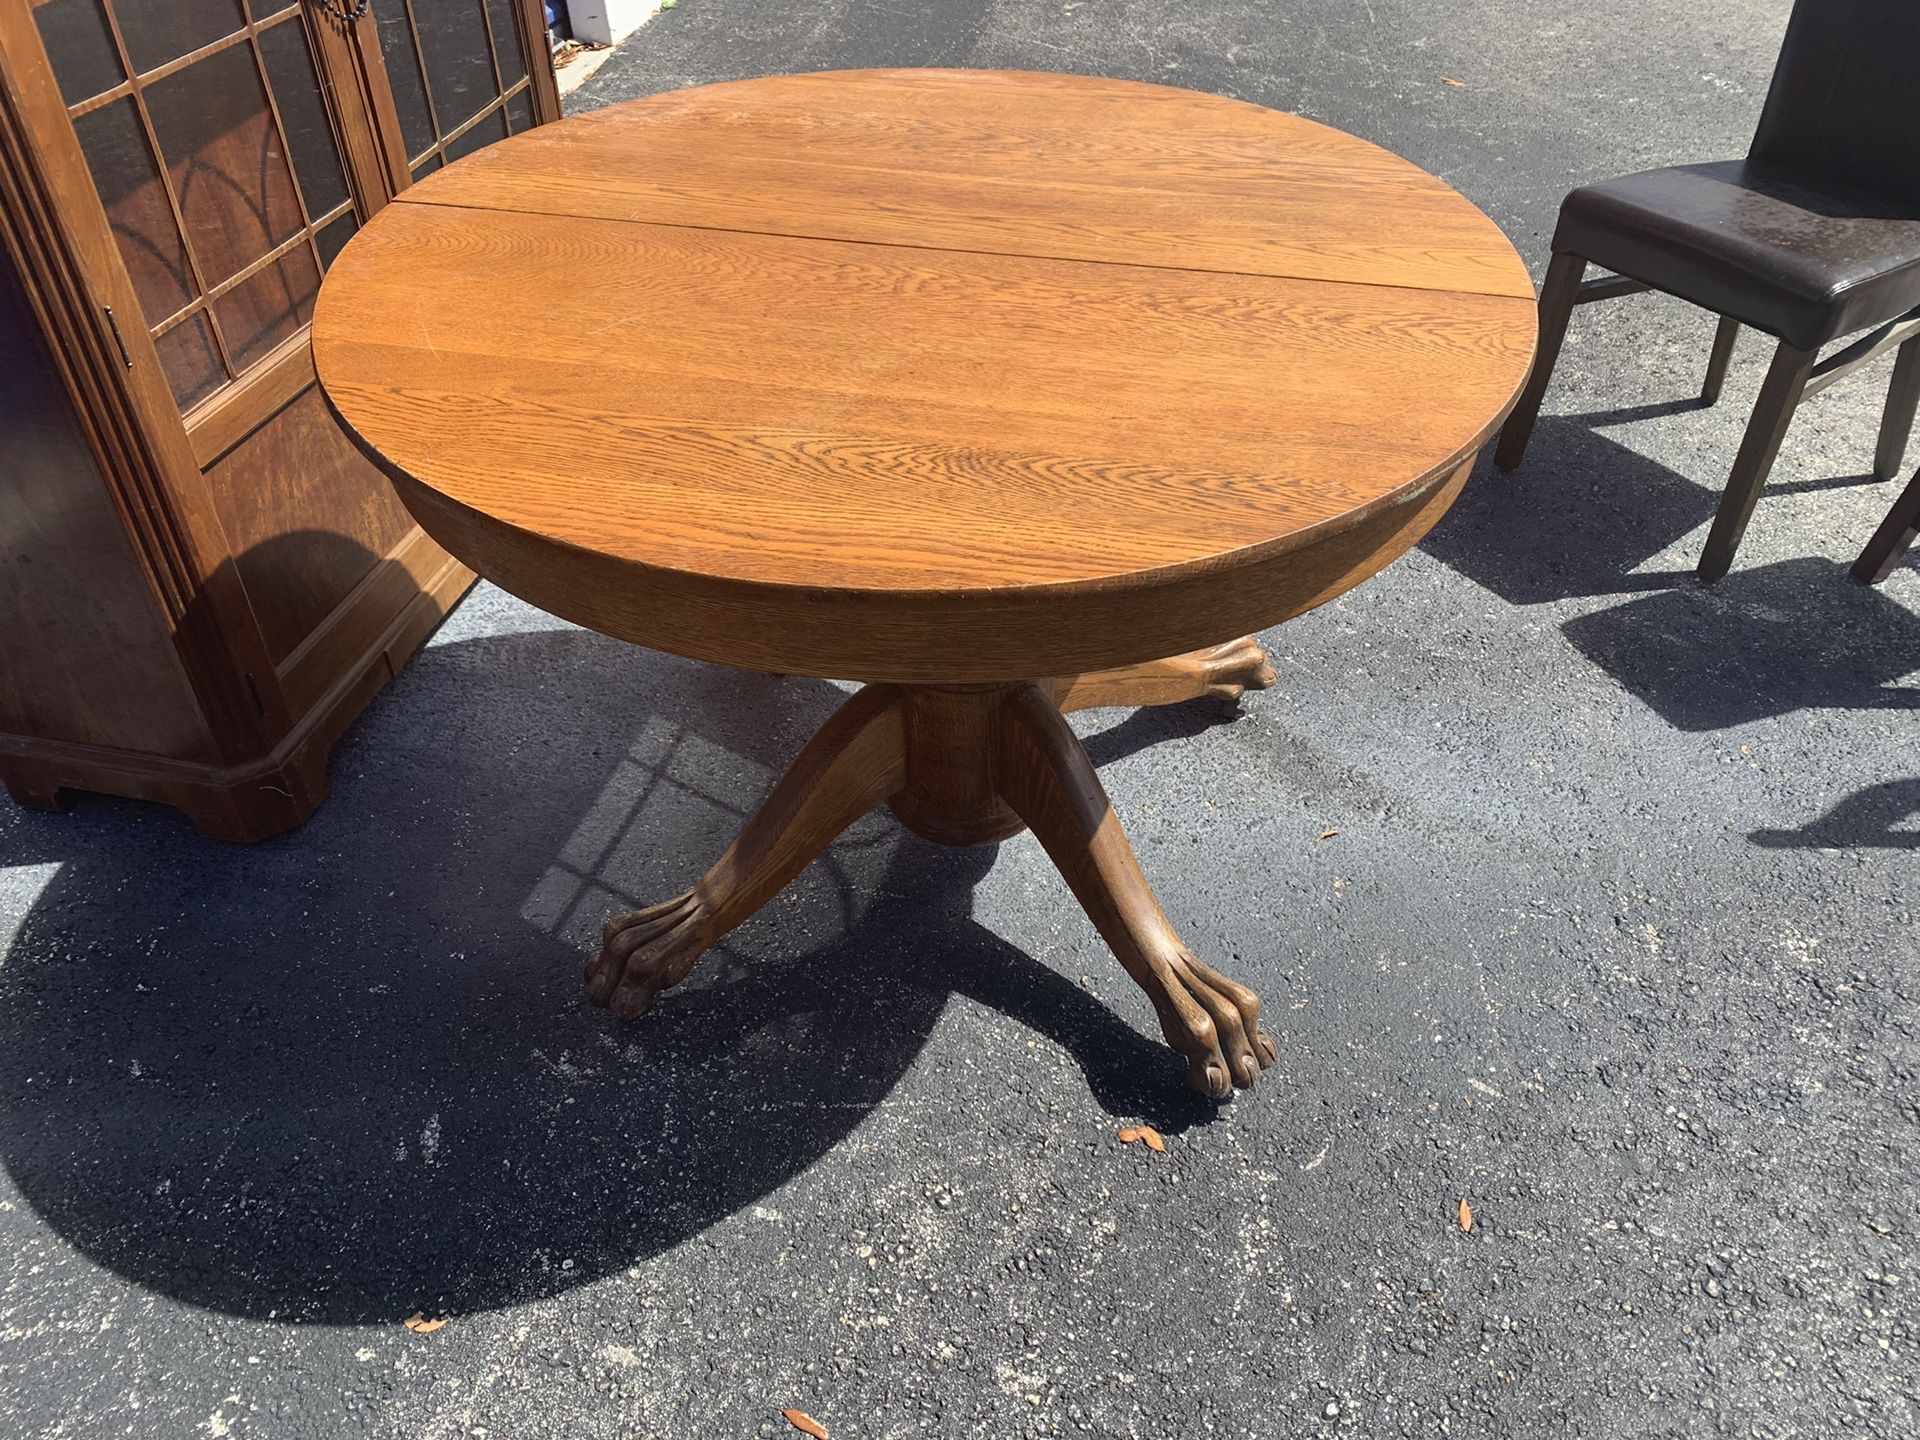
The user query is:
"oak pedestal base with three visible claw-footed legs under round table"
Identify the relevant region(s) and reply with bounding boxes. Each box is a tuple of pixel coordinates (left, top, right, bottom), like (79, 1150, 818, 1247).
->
(588, 639, 1275, 1100)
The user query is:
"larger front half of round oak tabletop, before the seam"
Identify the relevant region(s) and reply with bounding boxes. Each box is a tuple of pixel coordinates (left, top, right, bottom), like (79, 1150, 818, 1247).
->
(315, 207, 1532, 589)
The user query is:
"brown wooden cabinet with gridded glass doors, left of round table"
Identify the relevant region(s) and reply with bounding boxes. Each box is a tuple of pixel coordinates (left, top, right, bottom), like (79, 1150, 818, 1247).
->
(0, 0, 559, 839)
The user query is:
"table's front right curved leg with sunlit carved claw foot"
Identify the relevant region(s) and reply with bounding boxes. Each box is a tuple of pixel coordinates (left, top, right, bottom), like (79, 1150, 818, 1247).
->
(995, 685, 1275, 1100)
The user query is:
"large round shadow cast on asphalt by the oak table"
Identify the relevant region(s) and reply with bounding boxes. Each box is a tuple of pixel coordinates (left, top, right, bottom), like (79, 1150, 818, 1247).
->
(0, 630, 1212, 1323)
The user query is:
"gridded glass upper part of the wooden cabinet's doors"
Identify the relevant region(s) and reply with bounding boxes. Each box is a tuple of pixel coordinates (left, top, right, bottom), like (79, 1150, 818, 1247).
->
(33, 0, 559, 433)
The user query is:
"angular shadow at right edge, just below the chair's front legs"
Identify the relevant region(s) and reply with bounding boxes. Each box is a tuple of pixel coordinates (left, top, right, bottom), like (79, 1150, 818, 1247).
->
(1561, 557, 1920, 730)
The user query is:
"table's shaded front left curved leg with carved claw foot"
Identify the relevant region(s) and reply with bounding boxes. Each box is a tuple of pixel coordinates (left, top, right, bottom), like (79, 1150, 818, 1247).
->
(588, 685, 906, 1020)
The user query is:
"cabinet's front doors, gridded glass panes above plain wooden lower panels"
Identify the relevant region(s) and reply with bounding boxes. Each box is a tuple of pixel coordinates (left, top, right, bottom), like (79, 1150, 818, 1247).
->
(30, 0, 557, 714)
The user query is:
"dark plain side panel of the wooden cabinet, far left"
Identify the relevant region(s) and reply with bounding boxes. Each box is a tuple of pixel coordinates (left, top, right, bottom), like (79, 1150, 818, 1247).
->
(0, 231, 211, 760)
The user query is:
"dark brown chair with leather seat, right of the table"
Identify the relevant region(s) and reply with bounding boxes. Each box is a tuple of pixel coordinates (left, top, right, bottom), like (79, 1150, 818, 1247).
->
(1494, 0, 1920, 580)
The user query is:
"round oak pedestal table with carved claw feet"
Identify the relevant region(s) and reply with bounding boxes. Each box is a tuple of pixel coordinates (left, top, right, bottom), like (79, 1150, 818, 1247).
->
(313, 71, 1534, 1098)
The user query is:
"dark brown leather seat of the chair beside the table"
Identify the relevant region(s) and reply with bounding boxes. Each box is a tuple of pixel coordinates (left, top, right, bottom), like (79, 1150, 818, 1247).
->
(1553, 159, 1920, 349)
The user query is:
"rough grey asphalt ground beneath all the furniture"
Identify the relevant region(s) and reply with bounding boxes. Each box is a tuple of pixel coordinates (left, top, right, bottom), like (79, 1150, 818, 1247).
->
(0, 0, 1920, 1440)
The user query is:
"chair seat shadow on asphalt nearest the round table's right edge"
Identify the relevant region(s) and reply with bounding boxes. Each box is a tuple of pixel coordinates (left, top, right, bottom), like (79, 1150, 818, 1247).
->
(1421, 417, 1720, 605)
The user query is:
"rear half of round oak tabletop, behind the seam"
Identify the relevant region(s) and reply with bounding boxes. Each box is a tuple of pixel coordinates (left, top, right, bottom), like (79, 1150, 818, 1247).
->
(407, 71, 1532, 300)
